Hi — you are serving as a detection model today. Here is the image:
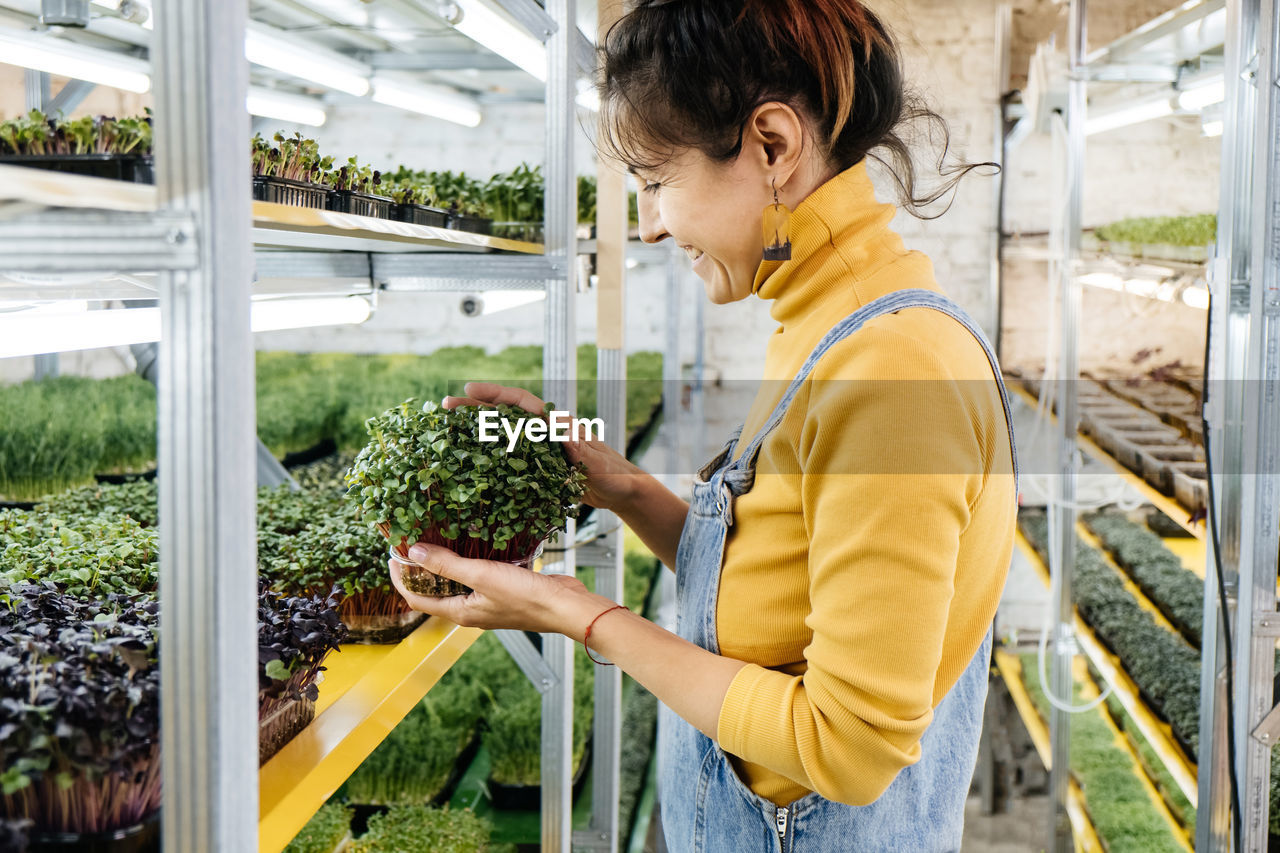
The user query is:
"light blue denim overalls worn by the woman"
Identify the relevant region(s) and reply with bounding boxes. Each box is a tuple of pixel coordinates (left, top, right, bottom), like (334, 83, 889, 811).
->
(659, 289, 1018, 853)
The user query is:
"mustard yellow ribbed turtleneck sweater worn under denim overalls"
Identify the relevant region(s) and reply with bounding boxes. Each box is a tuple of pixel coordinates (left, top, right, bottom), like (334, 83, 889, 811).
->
(717, 159, 1016, 806)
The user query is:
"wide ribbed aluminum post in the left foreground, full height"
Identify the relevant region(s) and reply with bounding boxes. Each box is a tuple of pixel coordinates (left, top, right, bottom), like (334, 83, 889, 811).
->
(151, 0, 257, 853)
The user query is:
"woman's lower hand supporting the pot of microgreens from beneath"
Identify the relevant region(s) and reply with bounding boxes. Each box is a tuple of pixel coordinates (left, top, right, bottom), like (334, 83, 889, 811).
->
(390, 543, 591, 634)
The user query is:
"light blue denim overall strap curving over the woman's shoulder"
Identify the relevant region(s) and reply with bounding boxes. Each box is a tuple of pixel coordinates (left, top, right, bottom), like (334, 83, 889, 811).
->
(724, 288, 1018, 493)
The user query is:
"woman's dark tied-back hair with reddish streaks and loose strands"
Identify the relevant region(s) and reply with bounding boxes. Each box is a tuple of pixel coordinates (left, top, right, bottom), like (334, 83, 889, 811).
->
(600, 0, 998, 219)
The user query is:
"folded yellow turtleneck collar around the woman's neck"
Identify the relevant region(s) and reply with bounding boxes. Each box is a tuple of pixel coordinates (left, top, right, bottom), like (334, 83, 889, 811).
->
(753, 160, 897, 327)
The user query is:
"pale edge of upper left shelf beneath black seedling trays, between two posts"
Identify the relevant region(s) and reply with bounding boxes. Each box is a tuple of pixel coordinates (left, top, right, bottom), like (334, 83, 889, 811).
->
(253, 201, 544, 255)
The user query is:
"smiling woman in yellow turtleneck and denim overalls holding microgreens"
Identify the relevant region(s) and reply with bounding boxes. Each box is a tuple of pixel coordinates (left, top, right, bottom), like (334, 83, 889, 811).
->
(392, 0, 1016, 853)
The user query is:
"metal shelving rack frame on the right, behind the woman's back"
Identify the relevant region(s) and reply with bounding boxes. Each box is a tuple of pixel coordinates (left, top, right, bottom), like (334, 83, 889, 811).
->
(1008, 0, 1280, 852)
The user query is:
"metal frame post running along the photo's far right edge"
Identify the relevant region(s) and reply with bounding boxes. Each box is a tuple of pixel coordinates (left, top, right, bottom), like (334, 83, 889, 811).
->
(1234, 0, 1280, 850)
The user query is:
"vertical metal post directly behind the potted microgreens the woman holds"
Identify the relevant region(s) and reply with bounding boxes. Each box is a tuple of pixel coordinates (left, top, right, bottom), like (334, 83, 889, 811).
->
(541, 0, 577, 853)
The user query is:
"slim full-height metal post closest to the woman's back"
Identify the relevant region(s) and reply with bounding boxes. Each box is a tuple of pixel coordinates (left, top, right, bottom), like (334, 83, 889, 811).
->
(1048, 0, 1088, 853)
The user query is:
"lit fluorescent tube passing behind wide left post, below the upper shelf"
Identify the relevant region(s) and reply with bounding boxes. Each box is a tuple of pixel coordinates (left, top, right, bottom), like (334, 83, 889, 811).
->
(0, 296, 371, 359)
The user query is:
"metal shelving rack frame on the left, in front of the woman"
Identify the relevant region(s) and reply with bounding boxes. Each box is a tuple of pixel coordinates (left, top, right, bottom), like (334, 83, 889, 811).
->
(0, 0, 640, 853)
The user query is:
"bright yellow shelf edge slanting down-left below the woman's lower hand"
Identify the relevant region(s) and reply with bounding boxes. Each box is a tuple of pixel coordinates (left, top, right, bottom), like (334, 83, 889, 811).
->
(259, 617, 483, 853)
